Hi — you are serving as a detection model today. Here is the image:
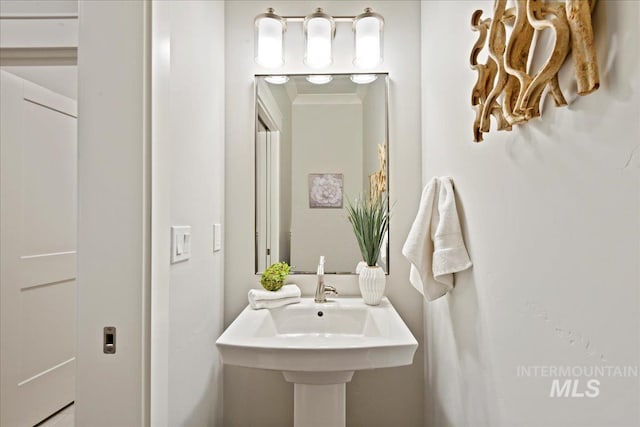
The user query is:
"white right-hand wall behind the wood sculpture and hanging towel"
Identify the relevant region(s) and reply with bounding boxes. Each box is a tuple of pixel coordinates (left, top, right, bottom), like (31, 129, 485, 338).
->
(422, 1, 640, 427)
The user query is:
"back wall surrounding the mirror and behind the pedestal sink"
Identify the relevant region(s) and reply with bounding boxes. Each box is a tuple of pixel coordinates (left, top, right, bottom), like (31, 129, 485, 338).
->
(224, 1, 424, 427)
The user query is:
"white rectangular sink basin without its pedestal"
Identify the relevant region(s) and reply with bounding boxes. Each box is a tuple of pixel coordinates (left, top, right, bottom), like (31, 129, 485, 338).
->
(216, 298, 418, 372)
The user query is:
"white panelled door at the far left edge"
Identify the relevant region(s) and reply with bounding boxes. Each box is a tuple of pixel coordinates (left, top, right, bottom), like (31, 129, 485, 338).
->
(0, 71, 77, 427)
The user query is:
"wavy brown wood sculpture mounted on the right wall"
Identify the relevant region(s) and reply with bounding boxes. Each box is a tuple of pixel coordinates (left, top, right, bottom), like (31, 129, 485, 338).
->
(470, 0, 600, 142)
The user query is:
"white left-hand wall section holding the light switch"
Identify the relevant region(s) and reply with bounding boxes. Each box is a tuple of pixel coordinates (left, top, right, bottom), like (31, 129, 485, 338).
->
(151, 1, 225, 426)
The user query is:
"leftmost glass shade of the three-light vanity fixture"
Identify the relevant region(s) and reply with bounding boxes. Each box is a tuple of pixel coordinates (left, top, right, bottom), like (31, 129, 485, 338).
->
(254, 8, 287, 68)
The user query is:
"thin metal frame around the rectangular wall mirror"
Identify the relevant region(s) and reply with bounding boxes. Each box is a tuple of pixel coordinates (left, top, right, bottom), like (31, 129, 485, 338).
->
(252, 72, 392, 276)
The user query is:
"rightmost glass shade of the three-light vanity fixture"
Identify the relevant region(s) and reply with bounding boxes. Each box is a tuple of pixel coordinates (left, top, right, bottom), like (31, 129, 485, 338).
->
(353, 8, 384, 69)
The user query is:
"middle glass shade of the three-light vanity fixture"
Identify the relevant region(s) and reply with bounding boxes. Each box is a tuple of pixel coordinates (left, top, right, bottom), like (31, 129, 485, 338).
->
(303, 9, 336, 69)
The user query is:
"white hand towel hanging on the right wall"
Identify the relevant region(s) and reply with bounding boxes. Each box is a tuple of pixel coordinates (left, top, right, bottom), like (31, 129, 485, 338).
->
(402, 177, 472, 301)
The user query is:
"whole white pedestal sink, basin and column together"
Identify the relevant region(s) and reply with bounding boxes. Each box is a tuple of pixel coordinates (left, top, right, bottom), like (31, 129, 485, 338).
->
(216, 298, 418, 427)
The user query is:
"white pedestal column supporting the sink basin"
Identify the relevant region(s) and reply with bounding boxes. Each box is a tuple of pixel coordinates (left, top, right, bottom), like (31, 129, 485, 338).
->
(283, 371, 353, 427)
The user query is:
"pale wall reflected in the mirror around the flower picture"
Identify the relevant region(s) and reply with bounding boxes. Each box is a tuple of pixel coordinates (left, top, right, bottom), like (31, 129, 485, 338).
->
(291, 99, 362, 272)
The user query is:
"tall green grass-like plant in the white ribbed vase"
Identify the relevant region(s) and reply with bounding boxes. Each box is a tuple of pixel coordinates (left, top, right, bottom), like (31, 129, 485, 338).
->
(347, 197, 389, 267)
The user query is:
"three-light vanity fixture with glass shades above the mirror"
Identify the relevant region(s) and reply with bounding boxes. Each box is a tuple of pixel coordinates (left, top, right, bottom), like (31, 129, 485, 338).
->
(254, 7, 384, 70)
